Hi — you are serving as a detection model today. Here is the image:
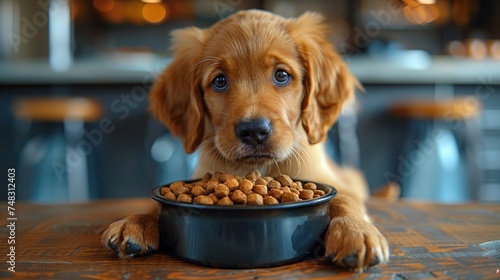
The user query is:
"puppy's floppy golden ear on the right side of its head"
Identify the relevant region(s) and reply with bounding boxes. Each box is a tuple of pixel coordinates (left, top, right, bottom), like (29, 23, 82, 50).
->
(290, 13, 361, 144)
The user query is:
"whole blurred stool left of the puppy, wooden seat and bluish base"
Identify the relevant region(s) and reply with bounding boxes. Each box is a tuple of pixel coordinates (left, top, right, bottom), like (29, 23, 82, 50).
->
(12, 97, 104, 203)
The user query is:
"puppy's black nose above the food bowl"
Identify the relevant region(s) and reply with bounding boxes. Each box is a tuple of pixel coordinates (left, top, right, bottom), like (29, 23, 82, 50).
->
(235, 119, 273, 147)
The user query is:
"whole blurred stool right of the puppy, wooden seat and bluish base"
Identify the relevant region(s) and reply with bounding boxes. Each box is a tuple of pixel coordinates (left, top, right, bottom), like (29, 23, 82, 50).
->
(389, 96, 481, 203)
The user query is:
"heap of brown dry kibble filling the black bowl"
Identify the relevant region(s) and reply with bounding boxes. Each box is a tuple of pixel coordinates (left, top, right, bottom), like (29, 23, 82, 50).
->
(161, 172, 325, 205)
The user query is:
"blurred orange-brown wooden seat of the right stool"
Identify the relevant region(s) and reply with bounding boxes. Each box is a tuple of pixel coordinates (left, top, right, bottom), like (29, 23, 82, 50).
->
(390, 96, 481, 120)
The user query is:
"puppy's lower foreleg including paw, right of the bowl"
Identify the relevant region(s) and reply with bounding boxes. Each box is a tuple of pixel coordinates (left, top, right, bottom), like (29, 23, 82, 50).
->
(325, 193, 389, 272)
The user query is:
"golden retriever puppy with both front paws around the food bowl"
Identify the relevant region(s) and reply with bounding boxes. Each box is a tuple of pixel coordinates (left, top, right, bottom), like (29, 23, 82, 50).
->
(102, 10, 389, 271)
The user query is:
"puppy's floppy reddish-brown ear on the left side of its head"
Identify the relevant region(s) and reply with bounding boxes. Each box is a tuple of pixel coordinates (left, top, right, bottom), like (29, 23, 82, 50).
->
(149, 27, 205, 153)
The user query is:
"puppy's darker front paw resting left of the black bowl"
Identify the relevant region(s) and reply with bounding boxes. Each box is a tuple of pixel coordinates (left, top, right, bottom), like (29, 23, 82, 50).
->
(101, 214, 160, 259)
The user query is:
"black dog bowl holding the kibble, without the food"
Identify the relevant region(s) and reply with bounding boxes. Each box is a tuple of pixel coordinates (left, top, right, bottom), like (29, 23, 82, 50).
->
(151, 181, 337, 268)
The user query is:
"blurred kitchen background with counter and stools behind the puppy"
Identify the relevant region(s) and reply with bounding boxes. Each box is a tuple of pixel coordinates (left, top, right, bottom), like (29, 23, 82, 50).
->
(0, 0, 500, 203)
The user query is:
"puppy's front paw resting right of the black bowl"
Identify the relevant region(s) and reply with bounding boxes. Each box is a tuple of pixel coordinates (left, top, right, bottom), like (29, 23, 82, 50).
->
(325, 217, 389, 272)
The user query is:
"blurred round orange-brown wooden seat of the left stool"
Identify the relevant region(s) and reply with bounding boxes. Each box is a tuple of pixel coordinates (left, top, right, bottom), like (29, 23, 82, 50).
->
(13, 97, 103, 122)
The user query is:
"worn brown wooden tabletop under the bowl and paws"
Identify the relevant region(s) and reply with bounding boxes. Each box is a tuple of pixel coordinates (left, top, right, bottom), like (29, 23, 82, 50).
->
(0, 199, 500, 280)
